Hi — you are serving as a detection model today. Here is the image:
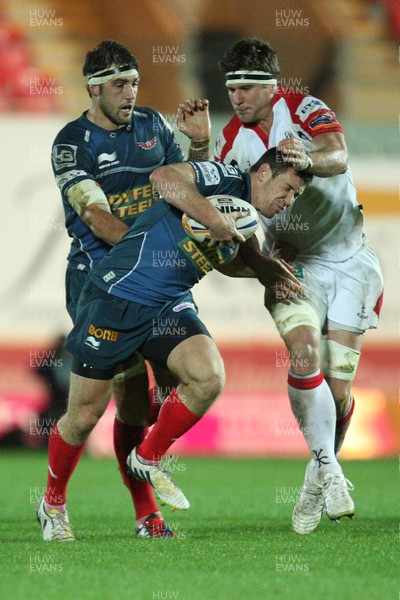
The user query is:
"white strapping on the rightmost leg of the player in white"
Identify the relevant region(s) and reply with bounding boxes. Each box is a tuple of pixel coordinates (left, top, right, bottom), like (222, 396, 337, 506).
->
(321, 340, 361, 382)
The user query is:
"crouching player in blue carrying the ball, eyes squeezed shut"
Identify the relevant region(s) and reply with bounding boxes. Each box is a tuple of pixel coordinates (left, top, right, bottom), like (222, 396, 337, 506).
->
(40, 149, 311, 541)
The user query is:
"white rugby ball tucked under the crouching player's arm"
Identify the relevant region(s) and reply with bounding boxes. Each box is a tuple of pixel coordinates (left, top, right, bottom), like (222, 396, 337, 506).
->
(182, 195, 260, 243)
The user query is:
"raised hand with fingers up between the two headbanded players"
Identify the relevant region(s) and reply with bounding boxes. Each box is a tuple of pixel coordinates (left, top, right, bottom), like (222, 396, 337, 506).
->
(176, 98, 211, 141)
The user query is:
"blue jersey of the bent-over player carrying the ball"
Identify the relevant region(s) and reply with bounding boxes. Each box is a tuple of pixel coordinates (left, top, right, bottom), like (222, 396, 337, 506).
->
(91, 161, 251, 306)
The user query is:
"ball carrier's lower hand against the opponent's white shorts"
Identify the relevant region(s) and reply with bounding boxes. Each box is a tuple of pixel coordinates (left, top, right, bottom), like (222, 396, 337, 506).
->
(257, 256, 301, 300)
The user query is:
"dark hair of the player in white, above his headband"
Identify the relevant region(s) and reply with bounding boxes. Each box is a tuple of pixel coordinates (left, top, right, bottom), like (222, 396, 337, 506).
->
(218, 37, 280, 75)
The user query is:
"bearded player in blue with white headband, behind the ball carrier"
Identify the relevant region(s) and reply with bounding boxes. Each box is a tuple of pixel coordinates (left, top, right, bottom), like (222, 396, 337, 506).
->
(39, 40, 210, 537)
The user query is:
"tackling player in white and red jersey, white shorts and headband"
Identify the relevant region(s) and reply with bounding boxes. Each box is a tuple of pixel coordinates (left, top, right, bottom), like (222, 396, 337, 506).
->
(215, 38, 383, 534)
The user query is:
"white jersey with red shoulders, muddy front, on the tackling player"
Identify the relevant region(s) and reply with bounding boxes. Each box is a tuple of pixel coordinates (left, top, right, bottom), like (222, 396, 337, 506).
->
(215, 88, 364, 263)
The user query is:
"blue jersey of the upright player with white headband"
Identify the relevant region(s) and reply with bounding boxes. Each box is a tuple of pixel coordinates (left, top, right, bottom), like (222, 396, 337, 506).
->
(52, 107, 183, 269)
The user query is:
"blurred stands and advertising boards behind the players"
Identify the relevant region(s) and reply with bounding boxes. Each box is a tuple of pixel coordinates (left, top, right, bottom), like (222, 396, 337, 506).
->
(0, 0, 400, 458)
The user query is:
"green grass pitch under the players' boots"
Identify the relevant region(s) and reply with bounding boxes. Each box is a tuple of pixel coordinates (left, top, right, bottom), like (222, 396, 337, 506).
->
(0, 449, 400, 600)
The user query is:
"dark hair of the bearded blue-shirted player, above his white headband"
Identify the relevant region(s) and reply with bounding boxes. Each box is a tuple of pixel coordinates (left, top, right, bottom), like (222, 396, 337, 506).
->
(82, 40, 139, 96)
